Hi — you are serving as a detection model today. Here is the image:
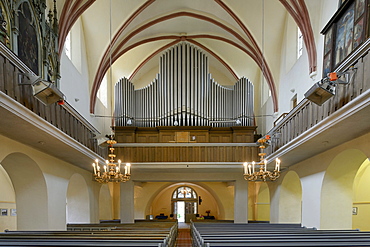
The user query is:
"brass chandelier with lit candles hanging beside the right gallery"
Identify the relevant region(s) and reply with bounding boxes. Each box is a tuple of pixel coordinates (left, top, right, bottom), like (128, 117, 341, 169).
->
(244, 136, 280, 181)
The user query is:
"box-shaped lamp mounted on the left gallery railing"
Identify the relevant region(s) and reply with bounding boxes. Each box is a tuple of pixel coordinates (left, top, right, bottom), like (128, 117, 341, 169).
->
(20, 73, 64, 105)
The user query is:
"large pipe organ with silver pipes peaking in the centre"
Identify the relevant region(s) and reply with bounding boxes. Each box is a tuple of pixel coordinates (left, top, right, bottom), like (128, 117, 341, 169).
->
(115, 42, 254, 127)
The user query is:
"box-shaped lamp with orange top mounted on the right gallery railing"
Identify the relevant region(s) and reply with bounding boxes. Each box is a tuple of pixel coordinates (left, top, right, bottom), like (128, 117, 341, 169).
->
(304, 67, 357, 106)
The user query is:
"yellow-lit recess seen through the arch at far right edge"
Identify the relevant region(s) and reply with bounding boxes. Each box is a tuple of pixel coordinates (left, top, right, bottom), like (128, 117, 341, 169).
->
(352, 159, 370, 231)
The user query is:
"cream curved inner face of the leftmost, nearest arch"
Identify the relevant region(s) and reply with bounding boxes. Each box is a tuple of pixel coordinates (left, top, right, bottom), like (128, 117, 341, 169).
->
(1, 153, 49, 230)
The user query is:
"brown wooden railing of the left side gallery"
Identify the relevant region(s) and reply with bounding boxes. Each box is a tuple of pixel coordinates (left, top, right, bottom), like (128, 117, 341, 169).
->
(0, 42, 106, 155)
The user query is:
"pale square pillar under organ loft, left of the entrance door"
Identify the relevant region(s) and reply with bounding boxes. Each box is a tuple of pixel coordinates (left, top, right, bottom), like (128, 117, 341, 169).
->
(120, 180, 135, 224)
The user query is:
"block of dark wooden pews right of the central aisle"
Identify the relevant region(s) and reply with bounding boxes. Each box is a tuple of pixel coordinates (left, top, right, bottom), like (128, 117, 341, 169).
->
(191, 223, 370, 247)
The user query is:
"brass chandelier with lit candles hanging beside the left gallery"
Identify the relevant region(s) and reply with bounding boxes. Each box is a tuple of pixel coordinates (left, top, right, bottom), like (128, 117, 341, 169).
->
(92, 140, 131, 184)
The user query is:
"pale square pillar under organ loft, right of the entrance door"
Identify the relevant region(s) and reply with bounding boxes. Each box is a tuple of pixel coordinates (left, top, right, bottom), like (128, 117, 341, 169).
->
(234, 179, 248, 223)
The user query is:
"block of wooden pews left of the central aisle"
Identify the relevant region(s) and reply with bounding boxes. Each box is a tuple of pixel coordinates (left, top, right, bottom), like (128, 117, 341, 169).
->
(0, 222, 178, 247)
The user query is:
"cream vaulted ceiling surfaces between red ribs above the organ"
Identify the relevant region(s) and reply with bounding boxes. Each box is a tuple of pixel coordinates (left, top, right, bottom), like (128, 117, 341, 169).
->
(58, 0, 287, 92)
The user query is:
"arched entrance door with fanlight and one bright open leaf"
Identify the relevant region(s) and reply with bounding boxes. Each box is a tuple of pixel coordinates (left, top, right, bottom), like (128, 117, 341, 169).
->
(171, 186, 198, 222)
